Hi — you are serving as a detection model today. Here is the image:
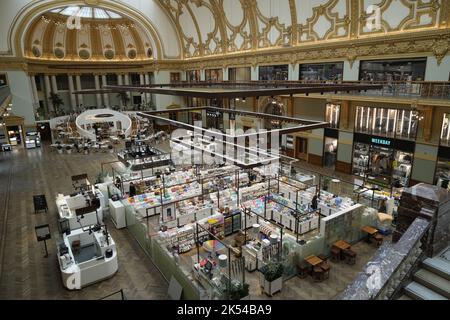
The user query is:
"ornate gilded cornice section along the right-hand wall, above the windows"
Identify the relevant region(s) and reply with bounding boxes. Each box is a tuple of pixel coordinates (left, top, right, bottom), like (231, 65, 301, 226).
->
(177, 29, 450, 69)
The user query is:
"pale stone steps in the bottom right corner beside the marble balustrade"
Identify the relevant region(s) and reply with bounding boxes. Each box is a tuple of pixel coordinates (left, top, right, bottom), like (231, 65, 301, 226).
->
(399, 247, 450, 300)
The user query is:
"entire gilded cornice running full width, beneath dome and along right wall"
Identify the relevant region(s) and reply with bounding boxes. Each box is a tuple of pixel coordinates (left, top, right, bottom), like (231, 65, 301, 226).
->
(0, 29, 450, 73)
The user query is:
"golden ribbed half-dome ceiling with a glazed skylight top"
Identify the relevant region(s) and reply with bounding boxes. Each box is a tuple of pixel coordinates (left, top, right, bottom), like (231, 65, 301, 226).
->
(25, 6, 155, 61)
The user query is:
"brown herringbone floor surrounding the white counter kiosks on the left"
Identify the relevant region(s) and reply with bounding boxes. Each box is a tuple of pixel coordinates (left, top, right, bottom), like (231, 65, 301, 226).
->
(0, 146, 168, 299)
